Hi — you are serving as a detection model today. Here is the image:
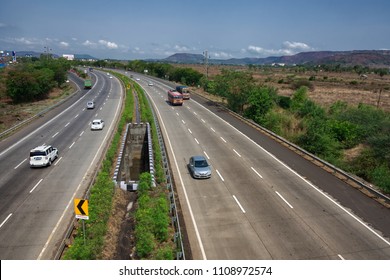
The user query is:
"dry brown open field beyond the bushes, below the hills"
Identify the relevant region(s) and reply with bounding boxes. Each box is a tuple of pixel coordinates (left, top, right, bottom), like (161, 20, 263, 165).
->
(175, 64, 390, 111)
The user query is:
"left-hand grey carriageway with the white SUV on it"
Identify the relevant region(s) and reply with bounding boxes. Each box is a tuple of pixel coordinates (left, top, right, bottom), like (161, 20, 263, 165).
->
(0, 71, 123, 260)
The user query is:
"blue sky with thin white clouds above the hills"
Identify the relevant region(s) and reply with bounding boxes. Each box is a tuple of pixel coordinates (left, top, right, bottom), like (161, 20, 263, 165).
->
(0, 0, 390, 60)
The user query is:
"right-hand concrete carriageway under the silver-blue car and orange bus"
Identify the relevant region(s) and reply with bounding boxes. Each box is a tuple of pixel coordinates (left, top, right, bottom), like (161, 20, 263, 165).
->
(134, 75, 390, 260)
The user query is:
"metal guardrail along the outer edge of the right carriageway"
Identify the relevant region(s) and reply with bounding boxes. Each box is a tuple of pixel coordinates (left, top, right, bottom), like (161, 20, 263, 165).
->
(194, 92, 390, 207)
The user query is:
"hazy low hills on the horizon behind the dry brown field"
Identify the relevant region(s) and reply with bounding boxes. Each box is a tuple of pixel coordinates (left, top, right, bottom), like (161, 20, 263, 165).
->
(162, 50, 390, 67)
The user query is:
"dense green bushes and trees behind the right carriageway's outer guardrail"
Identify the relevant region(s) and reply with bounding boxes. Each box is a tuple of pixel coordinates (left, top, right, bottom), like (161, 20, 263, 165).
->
(203, 70, 390, 193)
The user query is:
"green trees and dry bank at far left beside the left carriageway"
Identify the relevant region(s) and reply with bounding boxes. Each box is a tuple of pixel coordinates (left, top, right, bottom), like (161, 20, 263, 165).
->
(0, 58, 74, 133)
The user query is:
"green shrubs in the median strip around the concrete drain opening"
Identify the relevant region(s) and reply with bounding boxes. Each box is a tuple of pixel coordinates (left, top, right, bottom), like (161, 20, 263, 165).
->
(63, 73, 177, 260)
